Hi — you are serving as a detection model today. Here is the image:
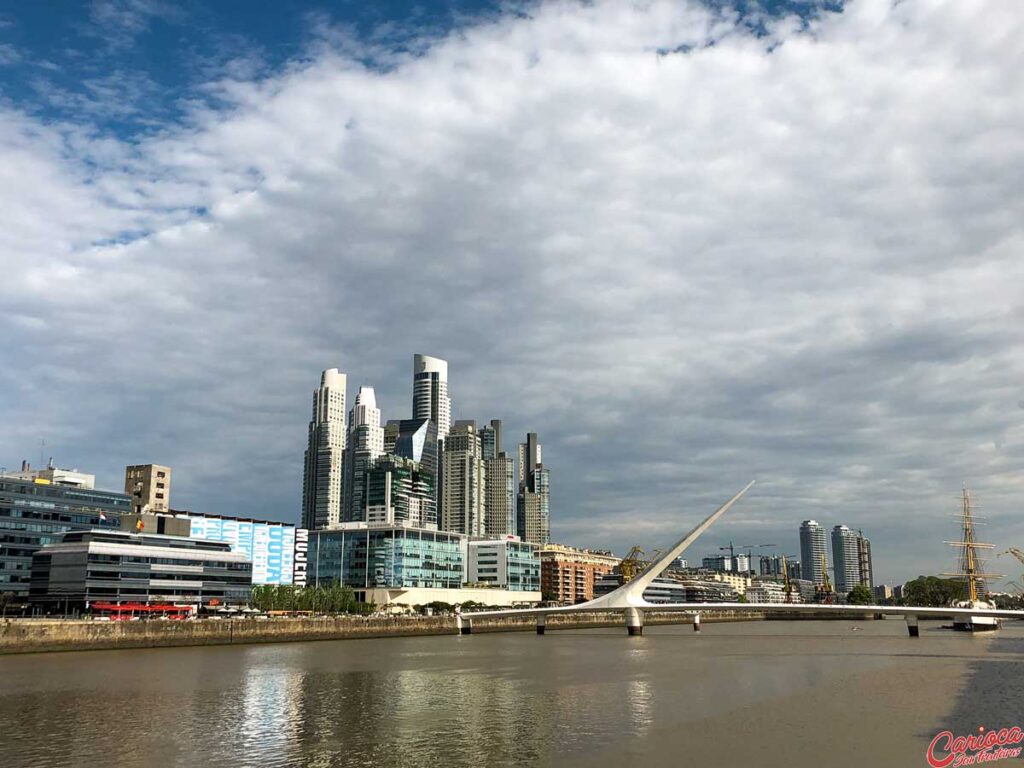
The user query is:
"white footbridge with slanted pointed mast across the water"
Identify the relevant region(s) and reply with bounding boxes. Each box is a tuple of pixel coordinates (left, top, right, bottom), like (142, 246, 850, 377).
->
(456, 480, 1024, 637)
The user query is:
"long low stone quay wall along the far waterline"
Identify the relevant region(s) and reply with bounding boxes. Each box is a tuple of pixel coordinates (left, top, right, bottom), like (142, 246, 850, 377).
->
(0, 612, 761, 654)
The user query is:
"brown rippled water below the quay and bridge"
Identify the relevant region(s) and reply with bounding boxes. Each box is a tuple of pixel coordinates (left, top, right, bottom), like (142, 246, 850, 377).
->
(0, 621, 1024, 768)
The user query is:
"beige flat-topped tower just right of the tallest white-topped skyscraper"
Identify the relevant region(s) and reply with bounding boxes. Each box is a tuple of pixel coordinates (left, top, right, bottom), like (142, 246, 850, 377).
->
(440, 421, 486, 536)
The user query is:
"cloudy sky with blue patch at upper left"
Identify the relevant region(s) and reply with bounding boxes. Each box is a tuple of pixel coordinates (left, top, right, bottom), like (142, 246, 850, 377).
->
(0, 0, 1024, 583)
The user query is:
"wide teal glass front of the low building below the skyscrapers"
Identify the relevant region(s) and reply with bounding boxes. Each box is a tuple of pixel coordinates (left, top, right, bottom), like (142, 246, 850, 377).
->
(307, 526, 465, 589)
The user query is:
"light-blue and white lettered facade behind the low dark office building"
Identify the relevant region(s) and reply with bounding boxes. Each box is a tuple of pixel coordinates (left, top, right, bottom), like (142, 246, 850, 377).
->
(172, 510, 296, 585)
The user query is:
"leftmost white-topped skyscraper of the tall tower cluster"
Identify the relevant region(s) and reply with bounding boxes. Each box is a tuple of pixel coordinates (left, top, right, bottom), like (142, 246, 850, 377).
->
(302, 368, 347, 528)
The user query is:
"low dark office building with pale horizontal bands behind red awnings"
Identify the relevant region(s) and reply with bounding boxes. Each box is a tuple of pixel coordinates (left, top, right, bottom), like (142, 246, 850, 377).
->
(29, 530, 252, 609)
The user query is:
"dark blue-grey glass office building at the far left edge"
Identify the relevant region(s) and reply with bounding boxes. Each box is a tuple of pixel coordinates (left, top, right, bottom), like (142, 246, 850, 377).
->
(0, 476, 131, 596)
